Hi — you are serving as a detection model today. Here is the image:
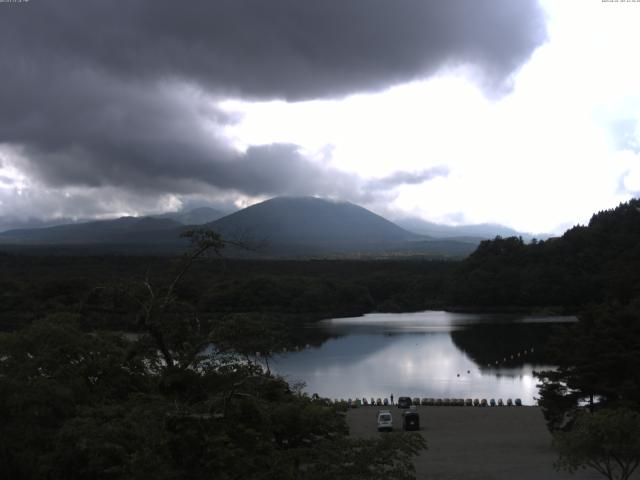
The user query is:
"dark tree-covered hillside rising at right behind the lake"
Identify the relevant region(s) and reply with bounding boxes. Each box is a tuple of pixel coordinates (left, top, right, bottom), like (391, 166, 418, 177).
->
(450, 199, 640, 309)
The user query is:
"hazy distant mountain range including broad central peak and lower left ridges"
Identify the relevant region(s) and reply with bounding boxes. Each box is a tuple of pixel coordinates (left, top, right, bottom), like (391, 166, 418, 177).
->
(0, 197, 478, 258)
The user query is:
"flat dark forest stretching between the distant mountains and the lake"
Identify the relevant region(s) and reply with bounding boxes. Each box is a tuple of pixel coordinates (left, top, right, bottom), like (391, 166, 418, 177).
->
(0, 253, 455, 330)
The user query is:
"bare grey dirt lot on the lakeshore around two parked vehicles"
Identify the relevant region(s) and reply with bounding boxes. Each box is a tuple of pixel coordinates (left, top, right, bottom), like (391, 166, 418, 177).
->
(347, 407, 608, 480)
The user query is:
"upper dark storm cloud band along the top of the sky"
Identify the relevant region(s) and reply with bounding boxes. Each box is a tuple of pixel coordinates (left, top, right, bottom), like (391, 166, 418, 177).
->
(0, 0, 545, 99)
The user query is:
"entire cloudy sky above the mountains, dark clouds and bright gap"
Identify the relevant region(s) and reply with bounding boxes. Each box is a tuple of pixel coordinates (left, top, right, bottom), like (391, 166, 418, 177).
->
(0, 0, 640, 233)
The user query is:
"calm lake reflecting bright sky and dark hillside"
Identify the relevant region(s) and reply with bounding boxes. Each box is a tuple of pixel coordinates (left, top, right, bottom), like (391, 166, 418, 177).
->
(271, 311, 575, 405)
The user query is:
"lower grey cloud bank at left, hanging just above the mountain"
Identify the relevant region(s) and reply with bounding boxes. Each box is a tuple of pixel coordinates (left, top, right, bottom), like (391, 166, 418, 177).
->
(2, 66, 355, 195)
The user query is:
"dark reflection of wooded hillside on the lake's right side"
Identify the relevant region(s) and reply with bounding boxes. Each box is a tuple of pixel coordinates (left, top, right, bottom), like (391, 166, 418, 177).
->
(451, 323, 554, 368)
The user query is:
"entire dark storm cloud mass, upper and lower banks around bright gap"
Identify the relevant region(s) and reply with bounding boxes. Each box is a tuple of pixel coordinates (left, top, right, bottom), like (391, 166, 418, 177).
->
(0, 0, 544, 212)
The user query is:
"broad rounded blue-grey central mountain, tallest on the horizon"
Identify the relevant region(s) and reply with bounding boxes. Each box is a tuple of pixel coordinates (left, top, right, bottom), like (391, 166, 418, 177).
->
(207, 197, 477, 257)
